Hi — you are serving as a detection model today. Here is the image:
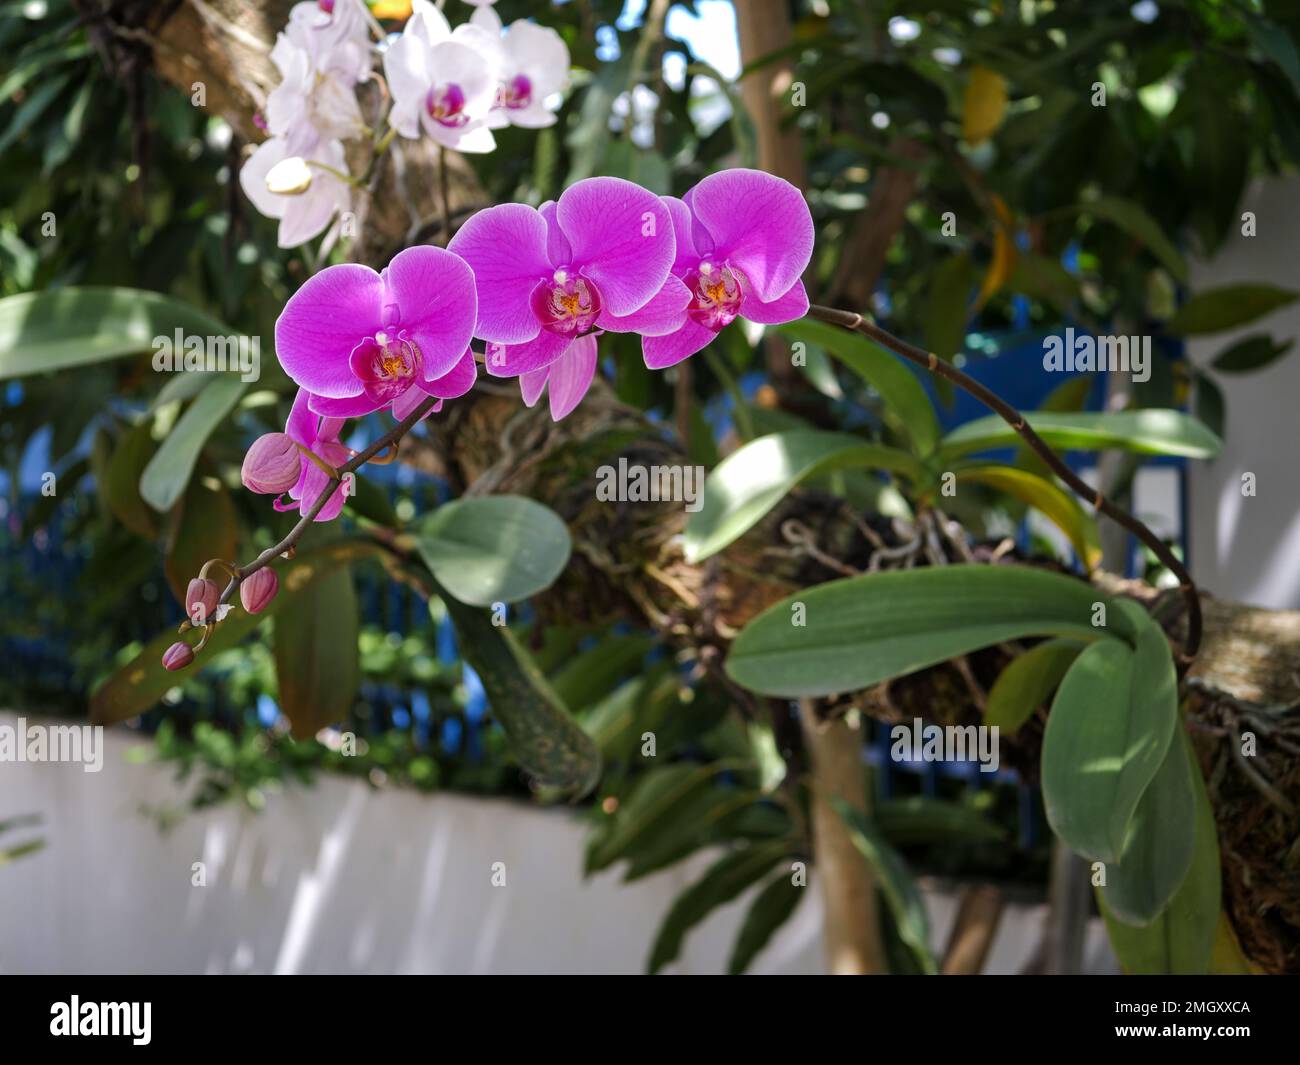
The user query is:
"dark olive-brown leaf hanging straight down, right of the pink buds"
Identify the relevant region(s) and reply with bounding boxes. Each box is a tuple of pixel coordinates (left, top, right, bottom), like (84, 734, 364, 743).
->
(272, 568, 361, 739)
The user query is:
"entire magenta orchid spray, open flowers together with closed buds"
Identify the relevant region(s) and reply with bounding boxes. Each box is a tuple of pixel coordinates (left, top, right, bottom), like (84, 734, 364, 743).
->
(163, 164, 813, 670)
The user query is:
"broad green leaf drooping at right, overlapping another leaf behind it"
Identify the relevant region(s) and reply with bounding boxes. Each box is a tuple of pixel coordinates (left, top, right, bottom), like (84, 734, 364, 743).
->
(1041, 599, 1178, 862)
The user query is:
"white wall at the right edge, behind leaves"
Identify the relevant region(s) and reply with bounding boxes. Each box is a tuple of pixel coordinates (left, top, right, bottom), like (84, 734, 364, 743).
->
(1188, 177, 1300, 609)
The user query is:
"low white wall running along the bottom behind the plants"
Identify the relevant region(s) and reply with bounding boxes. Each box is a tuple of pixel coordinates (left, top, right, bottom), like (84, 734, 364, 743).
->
(0, 714, 1113, 974)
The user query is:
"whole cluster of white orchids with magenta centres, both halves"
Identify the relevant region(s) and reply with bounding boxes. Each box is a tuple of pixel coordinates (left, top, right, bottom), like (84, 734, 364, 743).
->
(239, 0, 569, 247)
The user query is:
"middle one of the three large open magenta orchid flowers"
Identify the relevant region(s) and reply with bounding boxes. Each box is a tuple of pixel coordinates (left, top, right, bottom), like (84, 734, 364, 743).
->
(449, 177, 690, 403)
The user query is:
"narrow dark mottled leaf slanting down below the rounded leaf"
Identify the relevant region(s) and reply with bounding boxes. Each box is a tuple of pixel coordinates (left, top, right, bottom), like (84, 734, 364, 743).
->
(432, 574, 601, 797)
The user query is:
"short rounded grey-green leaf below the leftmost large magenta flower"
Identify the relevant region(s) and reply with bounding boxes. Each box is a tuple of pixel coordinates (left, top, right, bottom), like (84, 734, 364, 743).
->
(416, 495, 571, 606)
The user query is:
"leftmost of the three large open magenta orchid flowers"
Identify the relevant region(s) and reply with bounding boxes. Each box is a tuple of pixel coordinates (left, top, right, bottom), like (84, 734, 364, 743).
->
(276, 246, 478, 421)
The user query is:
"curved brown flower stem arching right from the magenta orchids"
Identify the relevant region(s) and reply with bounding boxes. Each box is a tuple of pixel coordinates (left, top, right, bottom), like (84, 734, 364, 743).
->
(809, 306, 1201, 672)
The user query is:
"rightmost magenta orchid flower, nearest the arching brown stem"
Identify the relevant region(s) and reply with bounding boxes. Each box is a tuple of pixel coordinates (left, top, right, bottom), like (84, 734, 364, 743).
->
(641, 169, 813, 369)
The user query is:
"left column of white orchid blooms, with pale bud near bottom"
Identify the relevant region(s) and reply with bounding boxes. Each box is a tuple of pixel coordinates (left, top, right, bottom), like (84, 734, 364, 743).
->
(239, 0, 371, 247)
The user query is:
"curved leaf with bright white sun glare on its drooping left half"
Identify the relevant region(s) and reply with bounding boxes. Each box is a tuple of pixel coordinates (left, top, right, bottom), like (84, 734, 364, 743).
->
(684, 429, 920, 563)
